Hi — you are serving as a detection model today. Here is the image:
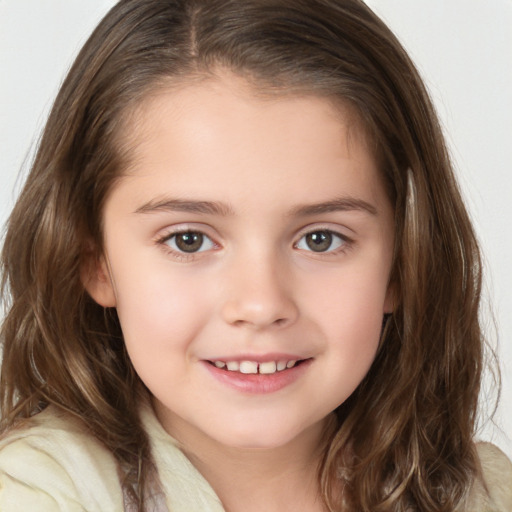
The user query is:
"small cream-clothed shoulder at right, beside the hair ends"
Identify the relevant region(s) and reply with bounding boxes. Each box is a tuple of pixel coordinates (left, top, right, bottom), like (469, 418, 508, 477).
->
(468, 443, 512, 512)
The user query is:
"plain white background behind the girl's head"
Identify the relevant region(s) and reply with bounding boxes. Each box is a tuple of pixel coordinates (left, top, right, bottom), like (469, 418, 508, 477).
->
(0, 0, 512, 458)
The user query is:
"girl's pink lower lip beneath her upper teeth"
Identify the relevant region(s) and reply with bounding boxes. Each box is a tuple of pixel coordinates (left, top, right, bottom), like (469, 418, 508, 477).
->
(204, 359, 313, 394)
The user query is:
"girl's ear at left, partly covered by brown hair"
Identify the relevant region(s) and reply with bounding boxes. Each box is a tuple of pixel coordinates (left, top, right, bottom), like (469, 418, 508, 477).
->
(80, 251, 117, 308)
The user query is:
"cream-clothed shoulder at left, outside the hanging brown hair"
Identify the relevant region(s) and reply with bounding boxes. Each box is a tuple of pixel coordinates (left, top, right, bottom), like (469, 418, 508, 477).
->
(0, 407, 123, 512)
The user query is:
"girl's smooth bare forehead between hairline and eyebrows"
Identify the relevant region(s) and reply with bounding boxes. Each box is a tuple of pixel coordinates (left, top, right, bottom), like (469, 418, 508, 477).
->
(107, 75, 388, 214)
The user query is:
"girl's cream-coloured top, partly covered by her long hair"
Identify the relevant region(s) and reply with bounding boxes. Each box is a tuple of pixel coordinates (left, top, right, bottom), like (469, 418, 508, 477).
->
(0, 407, 512, 512)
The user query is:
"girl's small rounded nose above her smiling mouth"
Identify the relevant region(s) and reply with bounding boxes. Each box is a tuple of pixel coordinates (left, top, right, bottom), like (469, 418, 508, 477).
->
(222, 256, 299, 330)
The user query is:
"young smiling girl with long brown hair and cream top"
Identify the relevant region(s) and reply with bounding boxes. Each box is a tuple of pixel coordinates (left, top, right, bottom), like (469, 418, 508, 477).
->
(0, 0, 512, 512)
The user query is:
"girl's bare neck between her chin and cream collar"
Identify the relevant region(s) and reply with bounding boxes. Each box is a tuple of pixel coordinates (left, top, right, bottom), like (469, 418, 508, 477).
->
(158, 410, 332, 512)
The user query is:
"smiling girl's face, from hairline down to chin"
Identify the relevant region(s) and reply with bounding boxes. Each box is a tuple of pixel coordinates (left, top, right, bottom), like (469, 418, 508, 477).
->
(87, 75, 393, 448)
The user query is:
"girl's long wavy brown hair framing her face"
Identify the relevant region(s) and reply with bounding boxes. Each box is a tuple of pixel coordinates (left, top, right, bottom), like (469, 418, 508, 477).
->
(0, 0, 484, 512)
